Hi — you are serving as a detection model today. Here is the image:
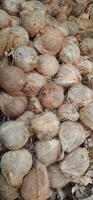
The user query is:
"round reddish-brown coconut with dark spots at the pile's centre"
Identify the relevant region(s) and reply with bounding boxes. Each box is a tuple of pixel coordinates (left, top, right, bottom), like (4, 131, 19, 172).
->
(39, 82, 64, 109)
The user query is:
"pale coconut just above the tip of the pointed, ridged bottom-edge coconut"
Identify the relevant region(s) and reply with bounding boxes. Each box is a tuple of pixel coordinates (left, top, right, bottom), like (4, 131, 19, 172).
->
(35, 139, 61, 166)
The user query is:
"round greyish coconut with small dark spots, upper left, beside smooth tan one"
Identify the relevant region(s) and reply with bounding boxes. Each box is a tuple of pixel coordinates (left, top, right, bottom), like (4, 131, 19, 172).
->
(14, 46, 39, 72)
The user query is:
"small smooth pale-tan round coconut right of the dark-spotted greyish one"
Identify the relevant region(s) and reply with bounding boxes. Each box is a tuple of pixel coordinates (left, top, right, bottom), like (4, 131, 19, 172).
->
(36, 54, 60, 77)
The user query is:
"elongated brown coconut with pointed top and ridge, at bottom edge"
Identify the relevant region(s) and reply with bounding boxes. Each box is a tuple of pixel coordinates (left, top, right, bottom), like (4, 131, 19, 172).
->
(21, 161, 49, 200)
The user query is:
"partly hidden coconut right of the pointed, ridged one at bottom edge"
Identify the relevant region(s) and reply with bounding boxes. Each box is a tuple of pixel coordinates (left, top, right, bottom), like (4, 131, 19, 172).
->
(48, 164, 69, 188)
